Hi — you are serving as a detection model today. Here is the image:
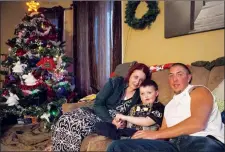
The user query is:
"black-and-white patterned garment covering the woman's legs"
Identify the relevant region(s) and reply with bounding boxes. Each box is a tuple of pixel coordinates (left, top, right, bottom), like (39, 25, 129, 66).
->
(52, 108, 101, 152)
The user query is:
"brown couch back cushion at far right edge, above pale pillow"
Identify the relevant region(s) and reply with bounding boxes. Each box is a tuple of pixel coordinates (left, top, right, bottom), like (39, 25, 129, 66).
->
(207, 66, 224, 90)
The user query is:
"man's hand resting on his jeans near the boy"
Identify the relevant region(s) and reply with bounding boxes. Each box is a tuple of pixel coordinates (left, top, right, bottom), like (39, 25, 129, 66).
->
(131, 130, 158, 139)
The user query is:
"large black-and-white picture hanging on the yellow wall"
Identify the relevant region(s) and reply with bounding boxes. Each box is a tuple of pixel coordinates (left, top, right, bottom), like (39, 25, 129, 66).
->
(164, 1, 224, 38)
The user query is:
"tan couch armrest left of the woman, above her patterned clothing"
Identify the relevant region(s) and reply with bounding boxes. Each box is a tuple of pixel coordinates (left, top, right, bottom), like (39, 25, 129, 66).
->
(62, 100, 94, 114)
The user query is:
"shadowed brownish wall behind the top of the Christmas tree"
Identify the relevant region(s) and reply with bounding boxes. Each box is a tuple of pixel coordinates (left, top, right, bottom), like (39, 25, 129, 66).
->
(0, 0, 73, 55)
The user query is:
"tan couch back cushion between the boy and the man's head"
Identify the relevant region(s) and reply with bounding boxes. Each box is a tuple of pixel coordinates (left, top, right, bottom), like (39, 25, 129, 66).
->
(152, 70, 173, 105)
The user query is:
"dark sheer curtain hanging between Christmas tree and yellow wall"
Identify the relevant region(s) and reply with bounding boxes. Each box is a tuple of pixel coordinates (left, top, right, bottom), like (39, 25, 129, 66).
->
(74, 1, 121, 96)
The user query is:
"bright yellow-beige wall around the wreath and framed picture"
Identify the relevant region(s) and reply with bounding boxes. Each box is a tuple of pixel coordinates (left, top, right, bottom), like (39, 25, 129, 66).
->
(122, 1, 224, 65)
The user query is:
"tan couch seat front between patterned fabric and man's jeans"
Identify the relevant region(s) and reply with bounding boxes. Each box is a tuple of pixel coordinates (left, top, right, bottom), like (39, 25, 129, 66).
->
(80, 134, 112, 151)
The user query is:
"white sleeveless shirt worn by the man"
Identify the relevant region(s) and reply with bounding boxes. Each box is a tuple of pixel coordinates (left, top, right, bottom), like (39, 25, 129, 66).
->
(164, 85, 224, 143)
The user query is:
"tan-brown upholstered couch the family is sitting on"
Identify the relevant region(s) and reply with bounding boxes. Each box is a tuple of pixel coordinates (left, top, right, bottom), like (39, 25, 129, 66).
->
(62, 63, 224, 151)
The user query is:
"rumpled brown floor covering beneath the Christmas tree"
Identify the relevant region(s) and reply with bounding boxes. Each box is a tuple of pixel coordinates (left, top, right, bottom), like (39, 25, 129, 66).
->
(0, 123, 51, 151)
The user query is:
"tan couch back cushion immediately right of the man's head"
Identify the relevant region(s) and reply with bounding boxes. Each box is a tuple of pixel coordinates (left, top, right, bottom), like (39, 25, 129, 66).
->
(190, 66, 210, 86)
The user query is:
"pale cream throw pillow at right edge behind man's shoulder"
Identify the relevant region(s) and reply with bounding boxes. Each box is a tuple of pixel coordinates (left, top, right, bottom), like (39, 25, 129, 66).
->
(212, 80, 225, 112)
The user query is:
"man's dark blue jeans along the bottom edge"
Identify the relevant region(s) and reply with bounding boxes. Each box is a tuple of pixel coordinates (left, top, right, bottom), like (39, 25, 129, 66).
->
(107, 135, 225, 152)
